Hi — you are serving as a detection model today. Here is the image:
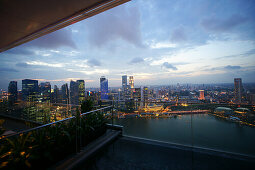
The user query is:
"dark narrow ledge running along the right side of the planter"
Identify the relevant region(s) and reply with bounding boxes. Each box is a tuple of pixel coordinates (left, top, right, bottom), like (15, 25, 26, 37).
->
(52, 130, 121, 170)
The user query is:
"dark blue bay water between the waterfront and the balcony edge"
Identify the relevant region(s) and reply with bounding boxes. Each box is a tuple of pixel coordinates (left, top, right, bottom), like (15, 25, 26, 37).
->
(114, 114, 255, 156)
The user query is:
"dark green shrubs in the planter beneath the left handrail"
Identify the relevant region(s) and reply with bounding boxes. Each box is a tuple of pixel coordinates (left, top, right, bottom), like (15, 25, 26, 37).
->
(0, 109, 106, 169)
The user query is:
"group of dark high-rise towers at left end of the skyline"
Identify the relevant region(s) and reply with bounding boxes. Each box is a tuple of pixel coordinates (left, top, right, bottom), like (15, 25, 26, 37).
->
(2, 79, 85, 105)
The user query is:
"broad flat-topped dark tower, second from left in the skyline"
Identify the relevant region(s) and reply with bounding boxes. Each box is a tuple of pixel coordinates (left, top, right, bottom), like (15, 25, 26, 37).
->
(22, 79, 39, 101)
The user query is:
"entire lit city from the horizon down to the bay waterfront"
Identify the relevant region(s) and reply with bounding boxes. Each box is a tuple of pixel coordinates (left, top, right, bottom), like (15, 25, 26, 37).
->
(0, 75, 255, 123)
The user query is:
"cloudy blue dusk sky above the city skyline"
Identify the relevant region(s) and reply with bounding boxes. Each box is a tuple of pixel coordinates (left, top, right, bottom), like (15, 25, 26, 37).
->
(0, 0, 255, 89)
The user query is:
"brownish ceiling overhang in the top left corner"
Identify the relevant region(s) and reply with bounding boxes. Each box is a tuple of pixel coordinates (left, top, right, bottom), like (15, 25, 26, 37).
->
(0, 0, 130, 52)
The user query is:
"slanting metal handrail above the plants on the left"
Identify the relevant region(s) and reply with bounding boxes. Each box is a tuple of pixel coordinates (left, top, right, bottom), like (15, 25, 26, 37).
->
(0, 106, 112, 141)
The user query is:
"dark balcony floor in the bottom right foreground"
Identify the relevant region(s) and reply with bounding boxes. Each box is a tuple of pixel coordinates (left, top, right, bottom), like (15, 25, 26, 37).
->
(81, 137, 255, 170)
